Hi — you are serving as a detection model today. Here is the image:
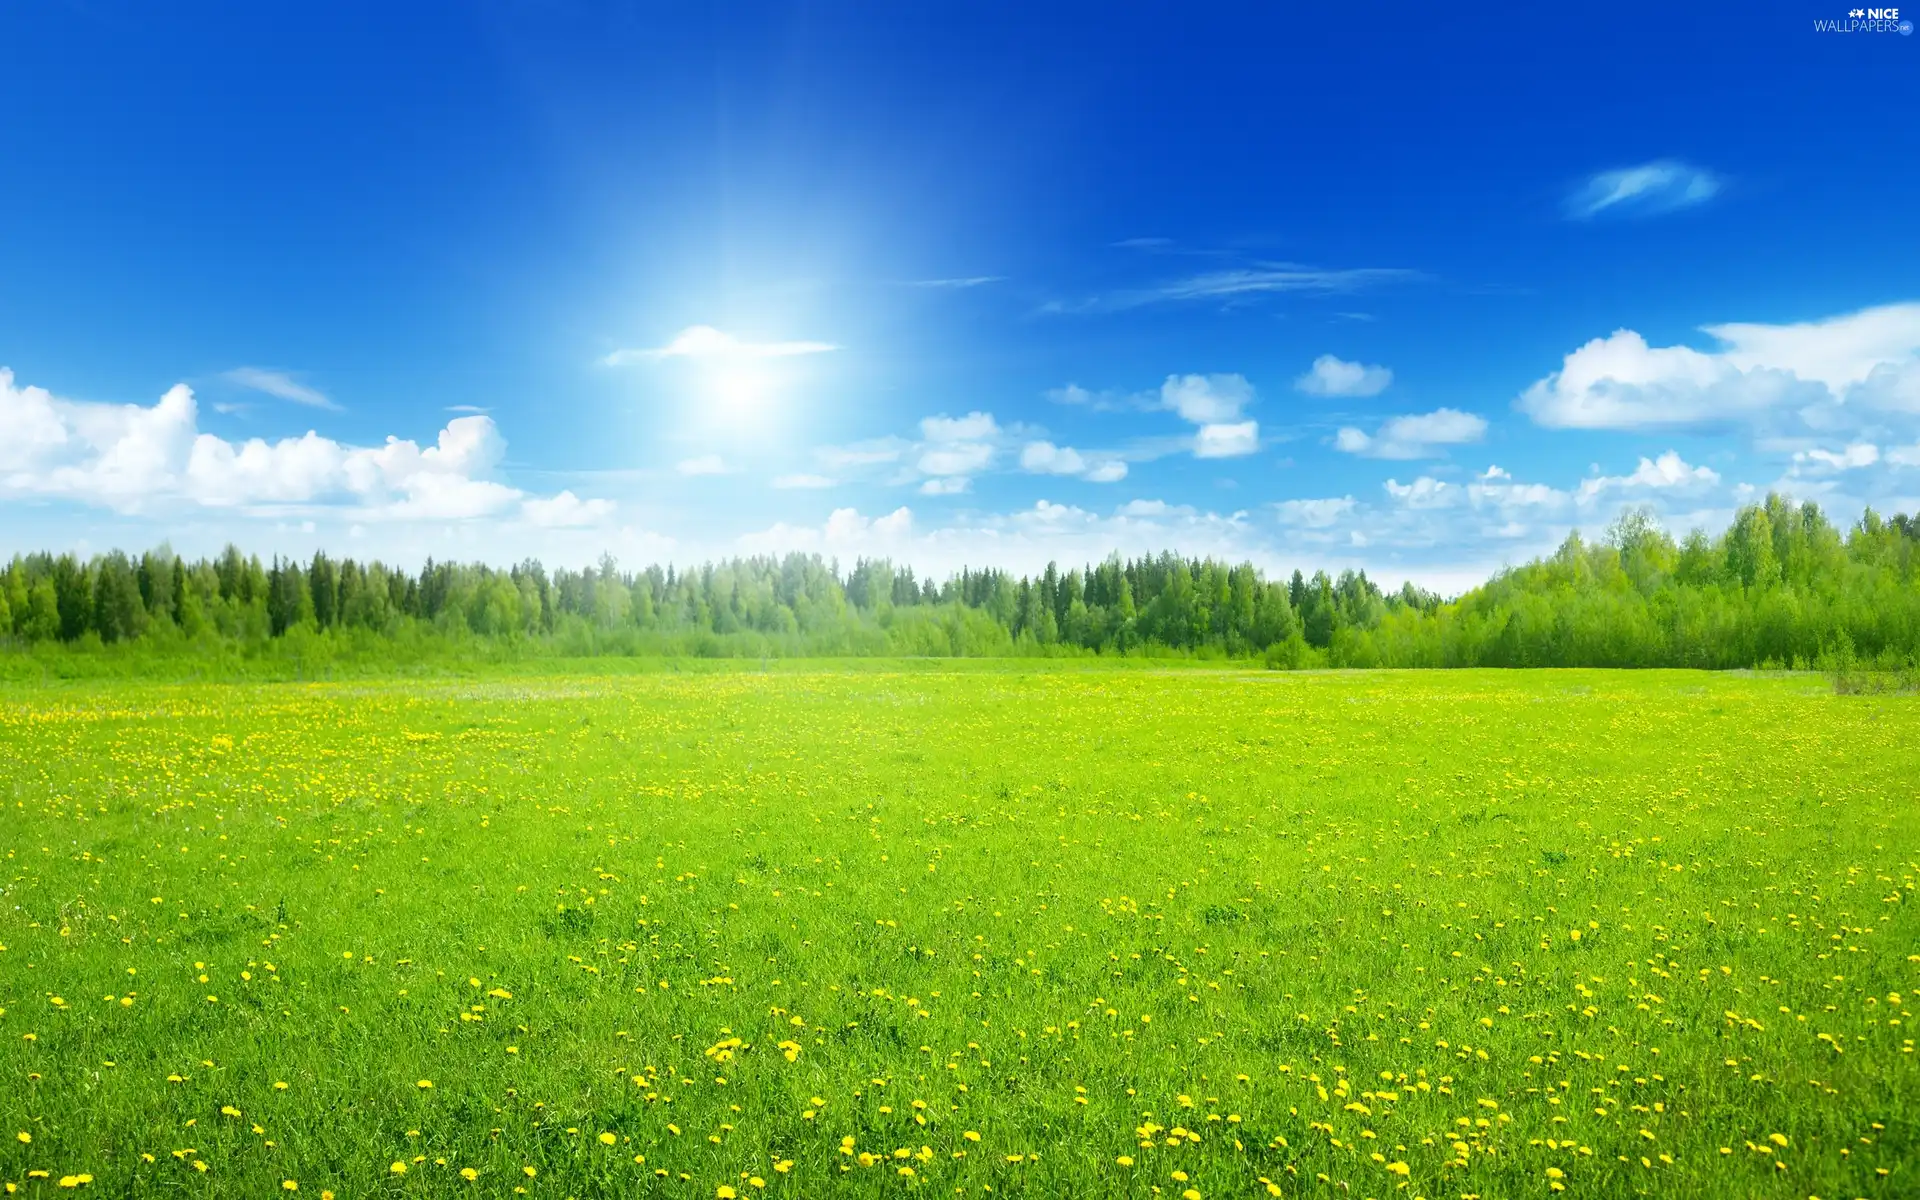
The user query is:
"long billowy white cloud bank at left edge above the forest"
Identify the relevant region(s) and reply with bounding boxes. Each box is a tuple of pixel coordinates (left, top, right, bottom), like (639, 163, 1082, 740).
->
(0, 369, 611, 524)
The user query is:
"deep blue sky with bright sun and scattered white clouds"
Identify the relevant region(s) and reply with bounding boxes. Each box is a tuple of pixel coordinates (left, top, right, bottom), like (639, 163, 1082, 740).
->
(0, 0, 1920, 591)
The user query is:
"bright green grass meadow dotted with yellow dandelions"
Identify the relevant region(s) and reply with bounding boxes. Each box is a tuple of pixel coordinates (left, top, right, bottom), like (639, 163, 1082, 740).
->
(0, 666, 1920, 1200)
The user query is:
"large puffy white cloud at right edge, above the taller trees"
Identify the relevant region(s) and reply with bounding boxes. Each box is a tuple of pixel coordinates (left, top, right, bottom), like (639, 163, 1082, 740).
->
(1517, 303, 1920, 428)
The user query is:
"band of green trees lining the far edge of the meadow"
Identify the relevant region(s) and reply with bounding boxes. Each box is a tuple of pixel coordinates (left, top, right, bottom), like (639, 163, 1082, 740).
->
(0, 495, 1920, 668)
